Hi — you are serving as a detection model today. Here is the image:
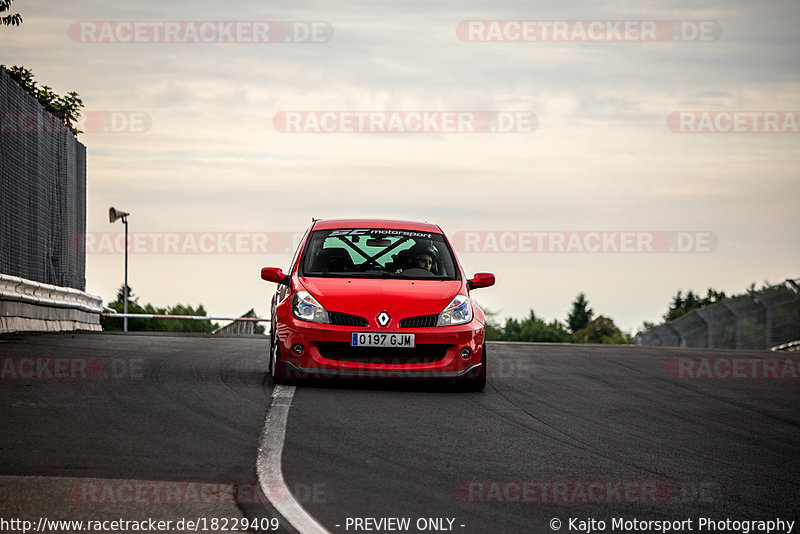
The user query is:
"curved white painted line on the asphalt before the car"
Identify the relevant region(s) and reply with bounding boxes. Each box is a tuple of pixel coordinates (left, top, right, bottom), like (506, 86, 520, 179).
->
(256, 385, 331, 534)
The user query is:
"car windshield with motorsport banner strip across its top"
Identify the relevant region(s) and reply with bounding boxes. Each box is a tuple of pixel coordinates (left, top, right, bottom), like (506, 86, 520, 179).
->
(300, 228, 461, 280)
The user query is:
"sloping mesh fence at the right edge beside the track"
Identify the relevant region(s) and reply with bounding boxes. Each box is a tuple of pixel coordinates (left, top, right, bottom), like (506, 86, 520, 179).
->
(634, 279, 800, 349)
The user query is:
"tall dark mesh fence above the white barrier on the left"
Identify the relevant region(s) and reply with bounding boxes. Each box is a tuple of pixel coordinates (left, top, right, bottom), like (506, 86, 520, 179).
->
(0, 70, 86, 290)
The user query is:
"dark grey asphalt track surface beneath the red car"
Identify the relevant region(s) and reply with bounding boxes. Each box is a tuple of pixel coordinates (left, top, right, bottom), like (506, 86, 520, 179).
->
(0, 333, 800, 533)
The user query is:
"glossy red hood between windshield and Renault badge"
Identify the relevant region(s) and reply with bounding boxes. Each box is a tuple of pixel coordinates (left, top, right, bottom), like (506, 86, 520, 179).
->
(299, 277, 463, 325)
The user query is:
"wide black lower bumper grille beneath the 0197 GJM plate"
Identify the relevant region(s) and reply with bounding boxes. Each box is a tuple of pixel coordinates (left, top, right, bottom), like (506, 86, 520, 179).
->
(317, 341, 450, 365)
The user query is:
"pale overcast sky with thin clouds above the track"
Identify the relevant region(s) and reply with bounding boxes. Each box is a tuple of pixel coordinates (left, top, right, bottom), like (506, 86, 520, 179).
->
(0, 0, 800, 331)
